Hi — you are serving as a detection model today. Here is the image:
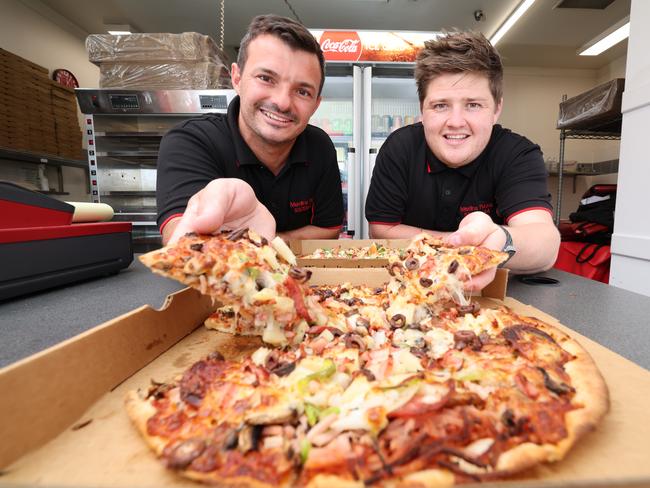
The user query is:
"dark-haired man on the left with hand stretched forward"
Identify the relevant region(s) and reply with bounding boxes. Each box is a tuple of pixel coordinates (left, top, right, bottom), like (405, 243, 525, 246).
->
(157, 15, 343, 243)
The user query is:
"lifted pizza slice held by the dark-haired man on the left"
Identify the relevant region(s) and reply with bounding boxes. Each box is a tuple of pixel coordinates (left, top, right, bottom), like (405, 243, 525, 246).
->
(140, 229, 322, 345)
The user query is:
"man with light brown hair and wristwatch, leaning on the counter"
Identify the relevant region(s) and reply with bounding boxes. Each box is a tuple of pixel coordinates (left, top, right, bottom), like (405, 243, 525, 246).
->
(366, 32, 560, 289)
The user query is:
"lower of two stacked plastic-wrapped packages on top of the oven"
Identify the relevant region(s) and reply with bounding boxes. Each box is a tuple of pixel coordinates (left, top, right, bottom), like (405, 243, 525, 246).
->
(99, 61, 232, 90)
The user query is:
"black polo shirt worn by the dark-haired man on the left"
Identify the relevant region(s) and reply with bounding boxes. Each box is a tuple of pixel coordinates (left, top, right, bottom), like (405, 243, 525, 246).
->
(156, 97, 343, 232)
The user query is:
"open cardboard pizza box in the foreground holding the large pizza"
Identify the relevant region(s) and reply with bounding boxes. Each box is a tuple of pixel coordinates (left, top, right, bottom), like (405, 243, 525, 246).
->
(0, 269, 650, 488)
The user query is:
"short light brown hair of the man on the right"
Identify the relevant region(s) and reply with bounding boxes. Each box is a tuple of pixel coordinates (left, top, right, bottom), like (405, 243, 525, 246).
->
(415, 31, 503, 104)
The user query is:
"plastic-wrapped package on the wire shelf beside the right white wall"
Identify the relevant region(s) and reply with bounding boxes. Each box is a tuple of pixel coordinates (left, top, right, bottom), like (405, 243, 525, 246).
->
(557, 78, 625, 132)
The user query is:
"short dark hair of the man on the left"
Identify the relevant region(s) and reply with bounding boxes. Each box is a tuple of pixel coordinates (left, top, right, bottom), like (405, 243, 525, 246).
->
(237, 14, 325, 95)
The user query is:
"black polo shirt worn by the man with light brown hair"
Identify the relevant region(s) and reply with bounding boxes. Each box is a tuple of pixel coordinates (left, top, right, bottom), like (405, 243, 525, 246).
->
(366, 123, 552, 231)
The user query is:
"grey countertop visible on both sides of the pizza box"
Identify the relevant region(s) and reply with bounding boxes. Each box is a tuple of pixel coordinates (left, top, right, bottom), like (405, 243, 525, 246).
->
(0, 259, 650, 369)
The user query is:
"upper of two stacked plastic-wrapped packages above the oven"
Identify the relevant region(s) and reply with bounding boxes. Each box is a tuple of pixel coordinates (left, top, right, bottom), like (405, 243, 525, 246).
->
(86, 32, 226, 66)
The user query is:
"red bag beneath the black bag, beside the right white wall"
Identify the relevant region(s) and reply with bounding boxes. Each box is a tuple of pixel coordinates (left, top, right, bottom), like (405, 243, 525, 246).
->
(553, 242, 612, 283)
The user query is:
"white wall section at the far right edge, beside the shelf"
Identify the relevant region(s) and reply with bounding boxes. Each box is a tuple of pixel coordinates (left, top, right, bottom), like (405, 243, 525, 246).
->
(610, 0, 650, 296)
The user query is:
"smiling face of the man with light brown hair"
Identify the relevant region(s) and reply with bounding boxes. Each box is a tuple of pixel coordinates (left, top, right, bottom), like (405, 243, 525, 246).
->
(421, 73, 502, 168)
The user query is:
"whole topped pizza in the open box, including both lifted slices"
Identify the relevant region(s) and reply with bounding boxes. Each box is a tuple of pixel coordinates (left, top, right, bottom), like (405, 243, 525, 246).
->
(132, 230, 609, 487)
